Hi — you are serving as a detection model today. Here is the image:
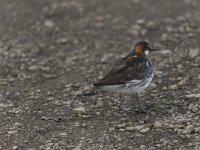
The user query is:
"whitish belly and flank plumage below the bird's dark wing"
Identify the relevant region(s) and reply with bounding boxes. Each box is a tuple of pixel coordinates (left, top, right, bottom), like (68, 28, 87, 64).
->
(103, 73, 153, 95)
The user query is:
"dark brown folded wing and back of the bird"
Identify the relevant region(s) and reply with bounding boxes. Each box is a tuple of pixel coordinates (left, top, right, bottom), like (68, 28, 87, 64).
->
(94, 55, 148, 86)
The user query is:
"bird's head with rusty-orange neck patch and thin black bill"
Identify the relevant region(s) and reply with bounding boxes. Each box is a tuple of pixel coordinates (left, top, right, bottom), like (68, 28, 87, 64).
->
(132, 41, 159, 56)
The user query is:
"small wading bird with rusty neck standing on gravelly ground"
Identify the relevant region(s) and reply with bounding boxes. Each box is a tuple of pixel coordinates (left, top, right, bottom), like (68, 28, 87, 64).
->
(94, 41, 159, 112)
